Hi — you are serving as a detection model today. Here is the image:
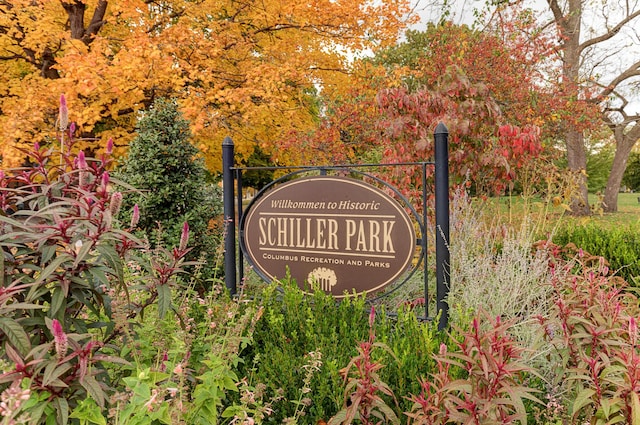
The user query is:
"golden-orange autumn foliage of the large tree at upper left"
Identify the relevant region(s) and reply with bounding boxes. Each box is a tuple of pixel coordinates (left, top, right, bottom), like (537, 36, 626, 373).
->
(0, 0, 416, 170)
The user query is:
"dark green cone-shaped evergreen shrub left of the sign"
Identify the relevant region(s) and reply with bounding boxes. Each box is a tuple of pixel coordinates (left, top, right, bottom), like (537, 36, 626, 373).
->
(115, 99, 222, 277)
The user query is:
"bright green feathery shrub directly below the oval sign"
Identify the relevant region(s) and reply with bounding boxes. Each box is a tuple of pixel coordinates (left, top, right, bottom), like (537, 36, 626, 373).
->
(239, 283, 448, 423)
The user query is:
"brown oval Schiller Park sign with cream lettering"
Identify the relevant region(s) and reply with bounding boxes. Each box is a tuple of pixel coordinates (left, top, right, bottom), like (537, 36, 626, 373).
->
(240, 176, 416, 297)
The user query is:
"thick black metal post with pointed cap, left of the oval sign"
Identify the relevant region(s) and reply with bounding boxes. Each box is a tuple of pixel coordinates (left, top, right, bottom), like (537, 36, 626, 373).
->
(222, 137, 237, 295)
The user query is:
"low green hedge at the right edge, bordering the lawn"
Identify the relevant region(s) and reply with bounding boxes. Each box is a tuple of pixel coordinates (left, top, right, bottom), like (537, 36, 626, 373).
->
(553, 224, 640, 284)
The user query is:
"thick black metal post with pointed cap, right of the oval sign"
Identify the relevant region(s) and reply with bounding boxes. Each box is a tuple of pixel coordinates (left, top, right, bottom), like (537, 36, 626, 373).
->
(433, 123, 451, 330)
